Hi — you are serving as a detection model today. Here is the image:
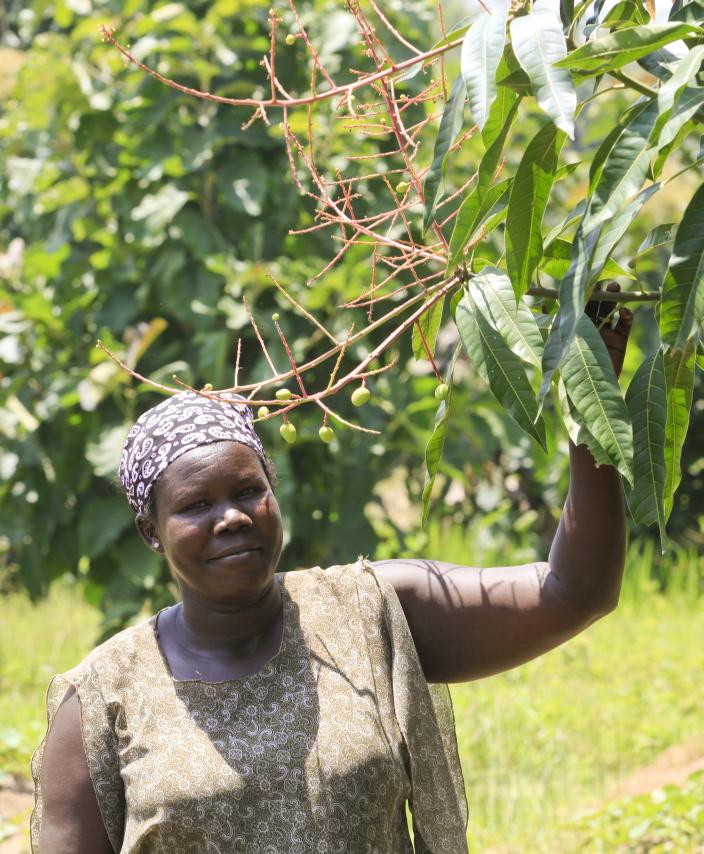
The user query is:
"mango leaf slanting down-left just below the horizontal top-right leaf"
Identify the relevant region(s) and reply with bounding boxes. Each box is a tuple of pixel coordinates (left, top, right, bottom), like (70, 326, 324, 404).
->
(583, 99, 658, 231)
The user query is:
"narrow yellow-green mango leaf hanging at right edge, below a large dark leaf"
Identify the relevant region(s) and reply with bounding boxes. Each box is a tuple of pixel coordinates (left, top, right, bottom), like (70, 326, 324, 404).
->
(664, 341, 696, 519)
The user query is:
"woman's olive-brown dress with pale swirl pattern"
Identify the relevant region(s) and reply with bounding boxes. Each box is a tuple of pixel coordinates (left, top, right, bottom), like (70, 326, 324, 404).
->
(31, 559, 467, 854)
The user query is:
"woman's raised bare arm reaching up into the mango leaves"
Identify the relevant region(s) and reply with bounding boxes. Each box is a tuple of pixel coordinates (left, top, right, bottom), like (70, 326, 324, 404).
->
(375, 300, 631, 682)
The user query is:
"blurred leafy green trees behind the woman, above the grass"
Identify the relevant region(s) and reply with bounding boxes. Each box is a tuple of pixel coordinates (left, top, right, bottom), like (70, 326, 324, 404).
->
(0, 0, 704, 625)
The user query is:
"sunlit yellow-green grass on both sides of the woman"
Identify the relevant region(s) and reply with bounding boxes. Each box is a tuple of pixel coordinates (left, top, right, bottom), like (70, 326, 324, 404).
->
(0, 576, 704, 854)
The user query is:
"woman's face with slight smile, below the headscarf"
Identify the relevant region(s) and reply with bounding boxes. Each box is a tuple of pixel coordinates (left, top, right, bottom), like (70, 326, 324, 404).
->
(138, 442, 283, 604)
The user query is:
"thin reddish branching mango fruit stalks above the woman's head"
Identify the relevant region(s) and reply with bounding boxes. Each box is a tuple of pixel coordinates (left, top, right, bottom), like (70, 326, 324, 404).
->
(99, 0, 656, 433)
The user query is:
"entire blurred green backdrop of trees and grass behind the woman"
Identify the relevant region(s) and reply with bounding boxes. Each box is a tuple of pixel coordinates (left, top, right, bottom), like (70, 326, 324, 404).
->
(0, 0, 704, 852)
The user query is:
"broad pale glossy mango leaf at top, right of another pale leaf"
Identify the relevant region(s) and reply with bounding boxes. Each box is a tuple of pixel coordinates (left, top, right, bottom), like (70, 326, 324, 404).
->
(511, 12, 577, 139)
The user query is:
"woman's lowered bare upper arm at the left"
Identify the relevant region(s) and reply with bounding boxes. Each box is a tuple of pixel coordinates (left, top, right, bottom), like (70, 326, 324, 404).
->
(40, 688, 113, 854)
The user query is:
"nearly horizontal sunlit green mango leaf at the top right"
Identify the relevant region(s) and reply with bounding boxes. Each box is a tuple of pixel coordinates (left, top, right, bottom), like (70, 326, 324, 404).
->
(556, 23, 704, 77)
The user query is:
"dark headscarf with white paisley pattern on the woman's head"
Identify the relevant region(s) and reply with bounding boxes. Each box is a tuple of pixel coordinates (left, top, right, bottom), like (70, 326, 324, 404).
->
(120, 391, 264, 513)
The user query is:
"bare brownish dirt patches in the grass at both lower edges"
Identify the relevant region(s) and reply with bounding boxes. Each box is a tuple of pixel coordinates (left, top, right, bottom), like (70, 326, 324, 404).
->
(0, 741, 704, 854)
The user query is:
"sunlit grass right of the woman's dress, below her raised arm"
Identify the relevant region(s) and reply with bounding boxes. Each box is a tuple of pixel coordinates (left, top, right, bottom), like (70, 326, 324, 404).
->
(452, 594, 704, 854)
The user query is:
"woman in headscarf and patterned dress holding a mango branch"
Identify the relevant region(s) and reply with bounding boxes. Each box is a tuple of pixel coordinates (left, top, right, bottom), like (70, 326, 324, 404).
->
(32, 309, 631, 854)
